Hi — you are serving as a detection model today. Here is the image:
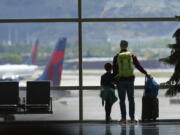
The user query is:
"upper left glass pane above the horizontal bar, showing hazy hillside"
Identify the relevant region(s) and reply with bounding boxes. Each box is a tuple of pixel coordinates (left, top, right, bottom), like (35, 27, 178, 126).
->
(0, 0, 78, 19)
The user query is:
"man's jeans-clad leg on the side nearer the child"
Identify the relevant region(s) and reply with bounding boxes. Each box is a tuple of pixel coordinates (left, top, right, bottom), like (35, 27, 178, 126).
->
(117, 81, 126, 119)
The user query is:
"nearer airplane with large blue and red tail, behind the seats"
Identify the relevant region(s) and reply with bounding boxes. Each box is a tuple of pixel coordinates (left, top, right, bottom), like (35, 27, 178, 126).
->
(37, 38, 75, 100)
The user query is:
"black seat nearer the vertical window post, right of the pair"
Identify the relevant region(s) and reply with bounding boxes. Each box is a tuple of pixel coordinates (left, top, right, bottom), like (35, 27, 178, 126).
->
(25, 81, 52, 113)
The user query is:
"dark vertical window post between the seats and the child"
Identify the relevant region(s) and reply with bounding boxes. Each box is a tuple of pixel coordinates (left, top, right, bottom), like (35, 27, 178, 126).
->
(78, 0, 83, 121)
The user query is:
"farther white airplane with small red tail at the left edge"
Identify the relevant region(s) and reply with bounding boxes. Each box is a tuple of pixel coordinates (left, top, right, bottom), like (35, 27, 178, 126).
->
(0, 40, 38, 81)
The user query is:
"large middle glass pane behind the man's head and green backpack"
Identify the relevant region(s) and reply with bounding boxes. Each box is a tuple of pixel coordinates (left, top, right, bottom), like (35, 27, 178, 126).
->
(83, 22, 180, 86)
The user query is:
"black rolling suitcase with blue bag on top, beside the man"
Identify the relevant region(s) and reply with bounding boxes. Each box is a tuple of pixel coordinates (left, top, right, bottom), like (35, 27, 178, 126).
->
(142, 77, 159, 121)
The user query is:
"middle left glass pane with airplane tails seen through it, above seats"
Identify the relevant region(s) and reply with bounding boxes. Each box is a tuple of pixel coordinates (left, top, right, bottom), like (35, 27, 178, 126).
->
(0, 23, 79, 86)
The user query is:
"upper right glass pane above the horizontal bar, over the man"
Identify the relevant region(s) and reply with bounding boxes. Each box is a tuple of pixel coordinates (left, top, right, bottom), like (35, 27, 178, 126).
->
(82, 0, 180, 18)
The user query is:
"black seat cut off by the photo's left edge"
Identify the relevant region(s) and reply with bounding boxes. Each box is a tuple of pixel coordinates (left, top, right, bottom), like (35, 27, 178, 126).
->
(0, 82, 20, 114)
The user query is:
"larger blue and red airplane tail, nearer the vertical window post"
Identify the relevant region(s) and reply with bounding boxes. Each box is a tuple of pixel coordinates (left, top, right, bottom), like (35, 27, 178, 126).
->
(37, 38, 66, 86)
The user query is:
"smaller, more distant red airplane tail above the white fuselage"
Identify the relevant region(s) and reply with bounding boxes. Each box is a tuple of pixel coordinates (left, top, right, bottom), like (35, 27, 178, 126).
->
(26, 39, 39, 65)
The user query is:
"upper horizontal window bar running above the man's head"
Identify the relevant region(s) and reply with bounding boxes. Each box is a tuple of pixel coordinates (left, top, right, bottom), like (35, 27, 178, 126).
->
(0, 16, 179, 23)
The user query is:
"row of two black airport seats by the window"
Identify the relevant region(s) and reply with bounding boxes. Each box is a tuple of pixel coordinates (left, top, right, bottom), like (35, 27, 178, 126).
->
(0, 81, 52, 114)
